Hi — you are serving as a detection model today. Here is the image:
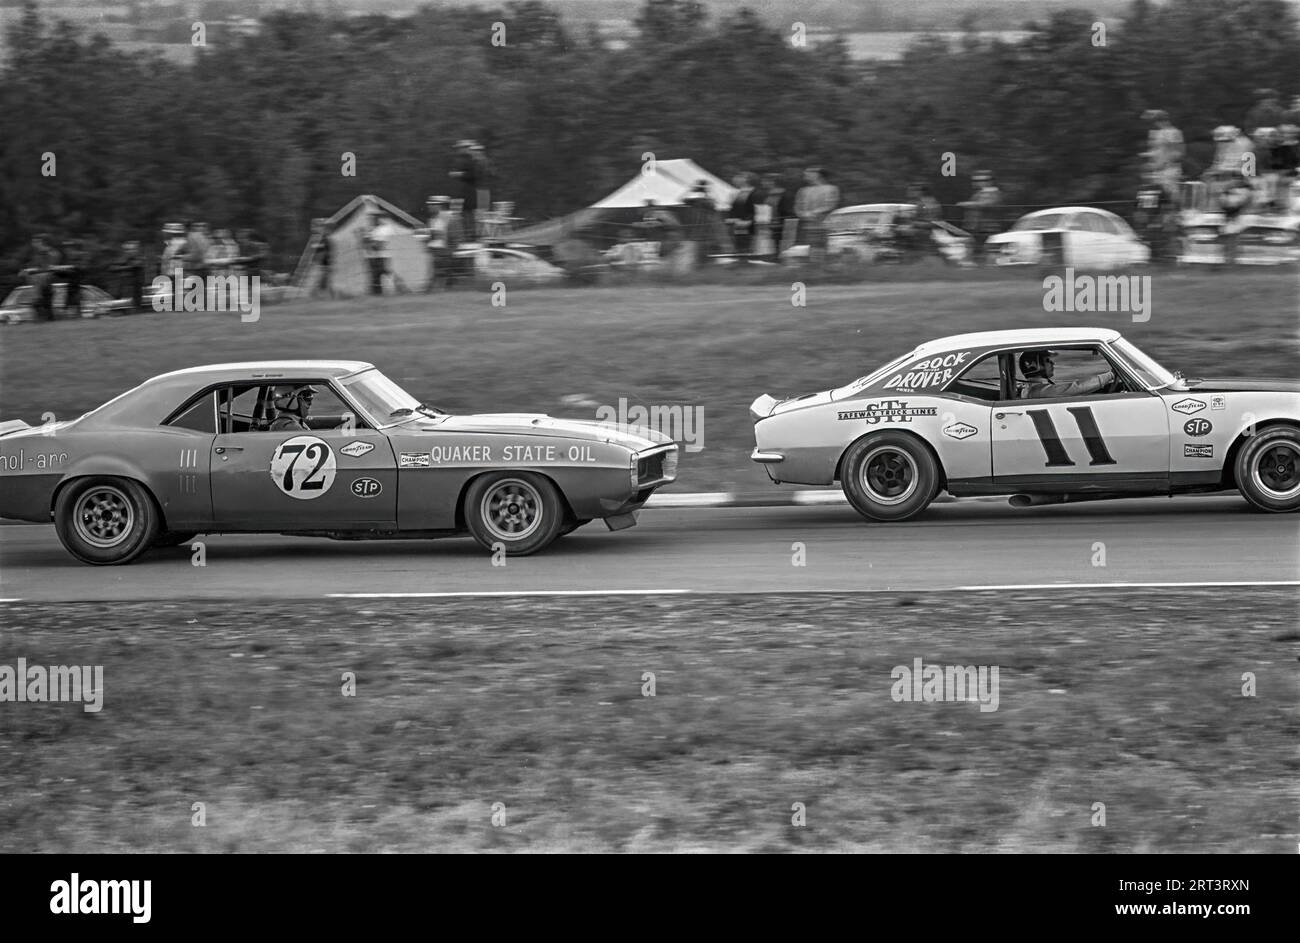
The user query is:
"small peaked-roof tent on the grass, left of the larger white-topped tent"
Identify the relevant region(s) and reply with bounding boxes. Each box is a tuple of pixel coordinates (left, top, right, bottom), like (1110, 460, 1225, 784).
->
(294, 194, 429, 297)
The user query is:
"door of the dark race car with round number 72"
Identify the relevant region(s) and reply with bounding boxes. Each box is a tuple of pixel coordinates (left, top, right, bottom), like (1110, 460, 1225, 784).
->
(211, 381, 397, 531)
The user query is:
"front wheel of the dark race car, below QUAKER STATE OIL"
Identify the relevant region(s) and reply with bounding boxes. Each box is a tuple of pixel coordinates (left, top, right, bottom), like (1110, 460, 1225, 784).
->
(464, 472, 564, 557)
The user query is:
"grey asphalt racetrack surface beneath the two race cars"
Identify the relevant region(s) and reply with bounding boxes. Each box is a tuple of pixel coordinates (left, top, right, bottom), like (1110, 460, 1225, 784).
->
(0, 496, 1300, 605)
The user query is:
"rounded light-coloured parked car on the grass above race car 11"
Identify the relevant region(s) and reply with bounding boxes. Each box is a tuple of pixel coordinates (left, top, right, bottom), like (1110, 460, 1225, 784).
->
(984, 207, 1151, 269)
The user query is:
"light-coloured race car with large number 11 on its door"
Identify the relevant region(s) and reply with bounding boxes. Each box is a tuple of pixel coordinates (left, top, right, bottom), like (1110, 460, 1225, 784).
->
(750, 328, 1300, 520)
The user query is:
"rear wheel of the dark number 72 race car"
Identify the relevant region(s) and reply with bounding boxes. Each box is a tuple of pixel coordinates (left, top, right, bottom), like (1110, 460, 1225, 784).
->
(55, 476, 160, 566)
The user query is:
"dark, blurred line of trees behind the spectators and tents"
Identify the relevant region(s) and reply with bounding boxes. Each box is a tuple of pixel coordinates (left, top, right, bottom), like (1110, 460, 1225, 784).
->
(0, 0, 1300, 287)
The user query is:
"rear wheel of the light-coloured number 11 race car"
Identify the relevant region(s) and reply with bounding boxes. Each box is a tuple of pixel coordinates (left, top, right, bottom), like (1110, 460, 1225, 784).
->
(840, 432, 939, 520)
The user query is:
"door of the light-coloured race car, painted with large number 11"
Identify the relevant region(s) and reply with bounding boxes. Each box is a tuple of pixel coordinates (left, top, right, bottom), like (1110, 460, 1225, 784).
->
(992, 351, 1169, 490)
